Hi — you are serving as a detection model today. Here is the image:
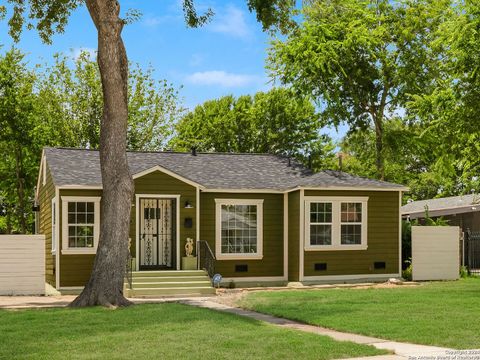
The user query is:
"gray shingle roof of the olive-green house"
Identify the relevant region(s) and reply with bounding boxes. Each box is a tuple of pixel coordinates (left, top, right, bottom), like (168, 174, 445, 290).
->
(45, 148, 405, 191)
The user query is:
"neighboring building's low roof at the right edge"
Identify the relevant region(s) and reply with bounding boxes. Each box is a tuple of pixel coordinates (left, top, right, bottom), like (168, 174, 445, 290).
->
(401, 194, 480, 215)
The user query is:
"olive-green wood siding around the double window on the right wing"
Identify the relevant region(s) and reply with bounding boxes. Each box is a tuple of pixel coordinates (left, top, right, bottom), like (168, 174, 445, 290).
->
(304, 191, 400, 276)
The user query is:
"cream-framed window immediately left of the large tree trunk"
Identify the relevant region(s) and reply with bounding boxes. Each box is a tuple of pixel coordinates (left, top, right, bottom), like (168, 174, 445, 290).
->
(62, 196, 100, 254)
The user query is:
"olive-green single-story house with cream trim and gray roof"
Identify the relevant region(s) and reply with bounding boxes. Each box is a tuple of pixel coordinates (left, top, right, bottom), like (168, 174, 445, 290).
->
(36, 148, 406, 296)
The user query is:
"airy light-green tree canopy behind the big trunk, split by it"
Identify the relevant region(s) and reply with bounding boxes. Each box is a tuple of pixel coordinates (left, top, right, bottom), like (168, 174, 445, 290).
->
(37, 52, 183, 150)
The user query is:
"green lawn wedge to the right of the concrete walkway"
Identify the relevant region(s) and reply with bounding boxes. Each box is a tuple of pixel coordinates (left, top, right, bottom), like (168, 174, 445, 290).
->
(239, 278, 480, 349)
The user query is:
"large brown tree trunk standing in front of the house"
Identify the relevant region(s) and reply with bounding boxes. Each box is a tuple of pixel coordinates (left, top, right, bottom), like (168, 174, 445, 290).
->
(71, 0, 133, 307)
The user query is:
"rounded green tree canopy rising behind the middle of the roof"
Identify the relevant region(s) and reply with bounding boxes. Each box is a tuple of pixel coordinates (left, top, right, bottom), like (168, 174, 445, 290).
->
(170, 88, 333, 166)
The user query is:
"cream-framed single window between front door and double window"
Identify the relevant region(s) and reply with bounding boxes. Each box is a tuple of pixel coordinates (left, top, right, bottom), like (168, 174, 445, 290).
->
(215, 199, 263, 260)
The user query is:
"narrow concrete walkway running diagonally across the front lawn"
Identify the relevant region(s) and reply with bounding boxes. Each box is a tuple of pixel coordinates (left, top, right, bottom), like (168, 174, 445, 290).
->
(179, 299, 453, 360)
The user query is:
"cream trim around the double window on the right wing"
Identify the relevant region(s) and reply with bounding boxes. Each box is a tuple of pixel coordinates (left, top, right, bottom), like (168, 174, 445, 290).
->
(304, 196, 368, 251)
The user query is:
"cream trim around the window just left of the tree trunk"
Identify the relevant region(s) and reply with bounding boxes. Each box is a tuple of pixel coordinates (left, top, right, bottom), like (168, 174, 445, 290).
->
(62, 196, 101, 255)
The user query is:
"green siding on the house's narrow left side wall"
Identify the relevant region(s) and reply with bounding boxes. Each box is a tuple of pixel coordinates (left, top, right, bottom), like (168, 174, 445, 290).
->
(38, 166, 58, 287)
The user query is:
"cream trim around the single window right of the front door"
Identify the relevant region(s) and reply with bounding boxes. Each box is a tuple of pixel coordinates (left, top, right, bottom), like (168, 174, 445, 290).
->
(215, 199, 263, 260)
